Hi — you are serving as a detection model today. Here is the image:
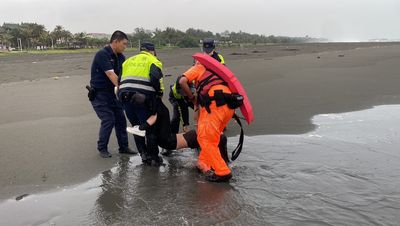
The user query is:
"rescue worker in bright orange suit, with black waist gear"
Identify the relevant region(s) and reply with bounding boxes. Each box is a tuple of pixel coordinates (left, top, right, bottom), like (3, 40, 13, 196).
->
(179, 56, 234, 182)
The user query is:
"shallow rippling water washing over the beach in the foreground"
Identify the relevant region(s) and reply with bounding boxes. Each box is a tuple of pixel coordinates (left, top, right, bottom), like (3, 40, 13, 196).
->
(0, 105, 400, 225)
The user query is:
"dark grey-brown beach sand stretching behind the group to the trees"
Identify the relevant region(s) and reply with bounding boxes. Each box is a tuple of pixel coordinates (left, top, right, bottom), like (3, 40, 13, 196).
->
(0, 43, 400, 199)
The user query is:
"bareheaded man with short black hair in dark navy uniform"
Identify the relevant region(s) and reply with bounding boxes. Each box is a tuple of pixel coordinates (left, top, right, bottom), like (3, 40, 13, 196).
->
(90, 31, 137, 158)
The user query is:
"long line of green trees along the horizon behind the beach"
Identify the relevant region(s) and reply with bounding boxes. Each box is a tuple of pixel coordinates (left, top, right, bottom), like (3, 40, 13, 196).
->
(0, 23, 318, 50)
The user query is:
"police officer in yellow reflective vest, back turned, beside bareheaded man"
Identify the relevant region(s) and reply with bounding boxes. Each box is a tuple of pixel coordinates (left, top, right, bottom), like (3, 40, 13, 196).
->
(119, 42, 164, 166)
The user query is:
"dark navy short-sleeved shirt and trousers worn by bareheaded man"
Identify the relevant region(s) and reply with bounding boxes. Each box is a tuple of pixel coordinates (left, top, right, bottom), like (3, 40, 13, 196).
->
(90, 46, 128, 152)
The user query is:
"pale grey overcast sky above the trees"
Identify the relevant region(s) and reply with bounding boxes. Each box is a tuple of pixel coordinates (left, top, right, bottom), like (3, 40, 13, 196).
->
(0, 0, 400, 41)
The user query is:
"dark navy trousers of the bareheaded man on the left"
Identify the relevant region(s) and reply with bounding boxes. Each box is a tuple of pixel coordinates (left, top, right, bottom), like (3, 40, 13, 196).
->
(91, 92, 128, 151)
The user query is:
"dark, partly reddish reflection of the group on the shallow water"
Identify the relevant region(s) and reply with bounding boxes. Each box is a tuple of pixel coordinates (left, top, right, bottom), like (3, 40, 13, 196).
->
(91, 153, 240, 225)
